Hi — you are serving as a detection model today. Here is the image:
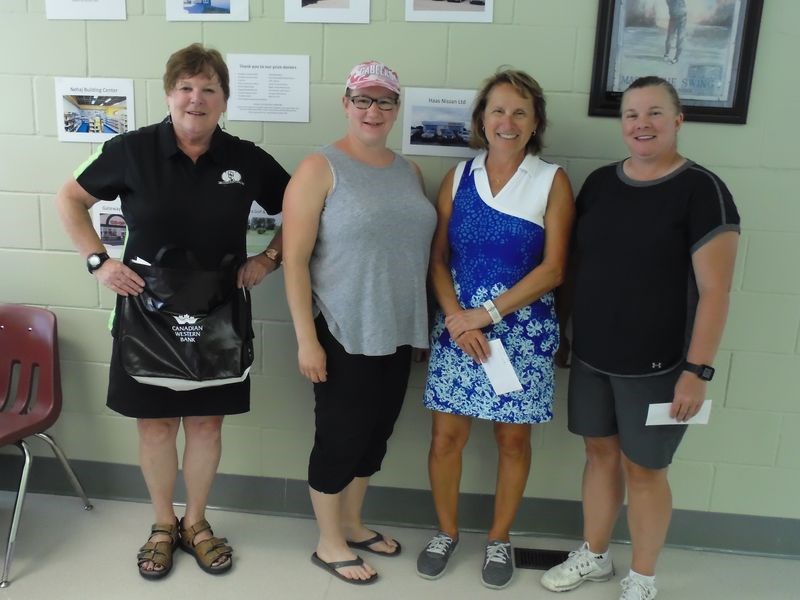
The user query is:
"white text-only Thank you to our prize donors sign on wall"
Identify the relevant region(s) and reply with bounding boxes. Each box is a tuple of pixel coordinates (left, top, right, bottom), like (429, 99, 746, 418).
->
(227, 54, 309, 123)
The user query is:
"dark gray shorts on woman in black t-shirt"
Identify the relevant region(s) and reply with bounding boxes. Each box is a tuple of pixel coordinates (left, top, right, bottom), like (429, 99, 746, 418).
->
(568, 355, 687, 469)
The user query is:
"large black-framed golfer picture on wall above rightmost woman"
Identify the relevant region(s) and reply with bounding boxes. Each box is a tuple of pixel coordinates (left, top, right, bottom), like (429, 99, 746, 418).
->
(589, 0, 763, 124)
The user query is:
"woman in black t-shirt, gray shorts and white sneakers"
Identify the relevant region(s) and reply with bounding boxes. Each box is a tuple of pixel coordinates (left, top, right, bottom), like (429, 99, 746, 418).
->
(542, 77, 739, 600)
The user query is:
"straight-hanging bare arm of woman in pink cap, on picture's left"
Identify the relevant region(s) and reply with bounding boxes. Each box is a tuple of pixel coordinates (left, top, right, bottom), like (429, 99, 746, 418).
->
(283, 154, 333, 383)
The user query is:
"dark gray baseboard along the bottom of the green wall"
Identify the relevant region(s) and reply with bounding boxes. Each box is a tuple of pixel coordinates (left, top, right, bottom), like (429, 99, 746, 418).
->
(0, 454, 800, 559)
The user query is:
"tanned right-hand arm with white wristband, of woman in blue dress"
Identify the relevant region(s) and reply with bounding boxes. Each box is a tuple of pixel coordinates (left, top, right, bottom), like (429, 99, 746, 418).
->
(446, 169, 575, 334)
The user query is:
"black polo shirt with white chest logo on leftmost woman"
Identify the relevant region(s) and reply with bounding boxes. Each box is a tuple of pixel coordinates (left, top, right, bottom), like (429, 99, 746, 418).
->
(75, 119, 289, 268)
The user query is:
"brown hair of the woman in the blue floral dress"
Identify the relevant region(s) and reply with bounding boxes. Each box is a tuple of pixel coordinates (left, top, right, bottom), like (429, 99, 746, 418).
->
(469, 67, 547, 154)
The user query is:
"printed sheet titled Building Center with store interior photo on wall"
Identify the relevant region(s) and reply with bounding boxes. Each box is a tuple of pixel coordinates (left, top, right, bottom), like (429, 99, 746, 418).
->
(55, 77, 135, 142)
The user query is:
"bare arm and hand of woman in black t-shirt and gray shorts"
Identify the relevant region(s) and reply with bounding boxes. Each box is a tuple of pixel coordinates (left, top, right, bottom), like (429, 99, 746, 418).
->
(670, 231, 739, 421)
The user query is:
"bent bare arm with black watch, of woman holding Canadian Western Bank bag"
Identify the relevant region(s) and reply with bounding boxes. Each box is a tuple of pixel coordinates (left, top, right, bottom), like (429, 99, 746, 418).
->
(55, 179, 144, 296)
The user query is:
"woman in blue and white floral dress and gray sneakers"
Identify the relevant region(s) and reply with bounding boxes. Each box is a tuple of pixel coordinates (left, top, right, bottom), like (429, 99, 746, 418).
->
(417, 70, 574, 588)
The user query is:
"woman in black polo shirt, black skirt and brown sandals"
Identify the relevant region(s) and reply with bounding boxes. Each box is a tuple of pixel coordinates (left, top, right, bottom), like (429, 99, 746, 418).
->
(56, 44, 289, 579)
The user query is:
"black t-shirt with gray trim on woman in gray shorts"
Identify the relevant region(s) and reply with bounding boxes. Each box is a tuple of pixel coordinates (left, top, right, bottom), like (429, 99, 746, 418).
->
(573, 161, 739, 376)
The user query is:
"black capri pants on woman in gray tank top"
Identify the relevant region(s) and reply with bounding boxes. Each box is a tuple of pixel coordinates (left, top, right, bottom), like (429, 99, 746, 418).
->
(308, 315, 411, 494)
